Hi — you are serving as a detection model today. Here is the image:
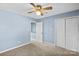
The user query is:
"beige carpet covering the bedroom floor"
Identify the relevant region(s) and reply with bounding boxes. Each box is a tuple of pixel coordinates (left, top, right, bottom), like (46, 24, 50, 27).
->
(0, 43, 79, 56)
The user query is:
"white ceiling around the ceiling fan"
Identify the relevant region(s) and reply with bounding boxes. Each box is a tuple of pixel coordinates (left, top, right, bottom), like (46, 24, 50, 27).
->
(0, 3, 79, 19)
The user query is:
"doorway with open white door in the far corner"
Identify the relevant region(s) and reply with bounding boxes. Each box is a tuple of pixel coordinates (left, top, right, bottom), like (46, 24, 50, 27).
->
(31, 22, 43, 42)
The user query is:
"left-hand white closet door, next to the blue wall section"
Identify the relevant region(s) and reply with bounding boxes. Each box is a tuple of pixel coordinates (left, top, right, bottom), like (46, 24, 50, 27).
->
(55, 19, 65, 48)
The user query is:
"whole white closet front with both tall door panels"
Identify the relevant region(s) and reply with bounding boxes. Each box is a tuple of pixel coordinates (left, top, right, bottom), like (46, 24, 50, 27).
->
(55, 16, 79, 52)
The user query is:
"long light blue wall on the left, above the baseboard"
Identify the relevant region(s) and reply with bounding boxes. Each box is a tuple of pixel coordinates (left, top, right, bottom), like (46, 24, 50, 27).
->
(0, 11, 31, 51)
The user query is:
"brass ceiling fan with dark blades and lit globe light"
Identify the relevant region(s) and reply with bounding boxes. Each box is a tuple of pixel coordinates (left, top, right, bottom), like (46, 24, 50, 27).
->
(28, 3, 53, 16)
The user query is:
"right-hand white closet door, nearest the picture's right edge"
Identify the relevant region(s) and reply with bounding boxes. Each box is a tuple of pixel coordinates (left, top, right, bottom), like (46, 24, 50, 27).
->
(66, 18, 78, 51)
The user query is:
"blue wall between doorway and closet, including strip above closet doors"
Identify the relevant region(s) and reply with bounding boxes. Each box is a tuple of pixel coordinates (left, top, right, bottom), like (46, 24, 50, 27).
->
(40, 10, 79, 43)
